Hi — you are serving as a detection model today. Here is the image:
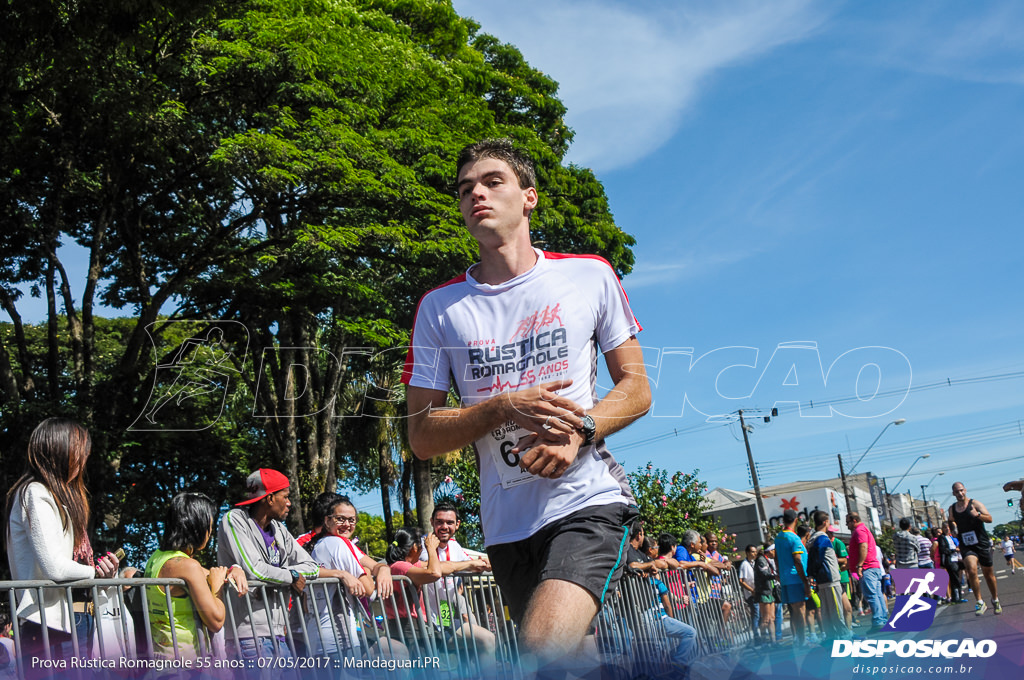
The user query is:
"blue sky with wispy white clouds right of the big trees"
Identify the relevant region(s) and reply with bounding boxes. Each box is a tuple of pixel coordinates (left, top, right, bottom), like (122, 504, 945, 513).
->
(455, 0, 1024, 521)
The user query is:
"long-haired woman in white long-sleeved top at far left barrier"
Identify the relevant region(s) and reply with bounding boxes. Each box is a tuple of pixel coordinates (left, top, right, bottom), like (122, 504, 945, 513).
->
(6, 418, 118, 656)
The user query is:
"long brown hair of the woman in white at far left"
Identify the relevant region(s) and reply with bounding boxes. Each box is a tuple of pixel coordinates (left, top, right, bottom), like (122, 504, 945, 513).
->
(6, 418, 92, 545)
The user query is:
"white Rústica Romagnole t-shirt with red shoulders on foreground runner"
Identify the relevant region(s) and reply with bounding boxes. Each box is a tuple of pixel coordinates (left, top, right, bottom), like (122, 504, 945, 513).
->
(402, 250, 640, 546)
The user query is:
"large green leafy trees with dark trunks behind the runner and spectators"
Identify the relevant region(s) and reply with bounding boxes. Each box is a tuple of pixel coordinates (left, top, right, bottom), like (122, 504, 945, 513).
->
(0, 0, 633, 565)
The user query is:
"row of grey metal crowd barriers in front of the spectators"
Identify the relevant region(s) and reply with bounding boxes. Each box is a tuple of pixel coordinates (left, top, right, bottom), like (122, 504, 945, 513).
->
(0, 570, 753, 680)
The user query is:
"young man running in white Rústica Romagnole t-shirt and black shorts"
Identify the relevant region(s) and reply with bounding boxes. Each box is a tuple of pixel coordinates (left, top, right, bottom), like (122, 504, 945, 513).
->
(402, 139, 651, 665)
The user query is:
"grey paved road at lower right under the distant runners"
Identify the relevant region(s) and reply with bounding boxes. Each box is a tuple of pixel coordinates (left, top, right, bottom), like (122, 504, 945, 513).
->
(690, 555, 1024, 680)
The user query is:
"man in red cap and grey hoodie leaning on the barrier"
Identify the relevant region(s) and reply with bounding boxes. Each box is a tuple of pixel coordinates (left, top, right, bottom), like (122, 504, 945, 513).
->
(217, 468, 340, 658)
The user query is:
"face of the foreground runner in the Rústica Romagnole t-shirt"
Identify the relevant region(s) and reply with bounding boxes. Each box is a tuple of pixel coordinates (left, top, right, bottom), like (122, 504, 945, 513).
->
(458, 158, 537, 245)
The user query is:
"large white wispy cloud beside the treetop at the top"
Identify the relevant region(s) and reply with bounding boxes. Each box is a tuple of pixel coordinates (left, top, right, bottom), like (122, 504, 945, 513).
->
(454, 0, 823, 170)
